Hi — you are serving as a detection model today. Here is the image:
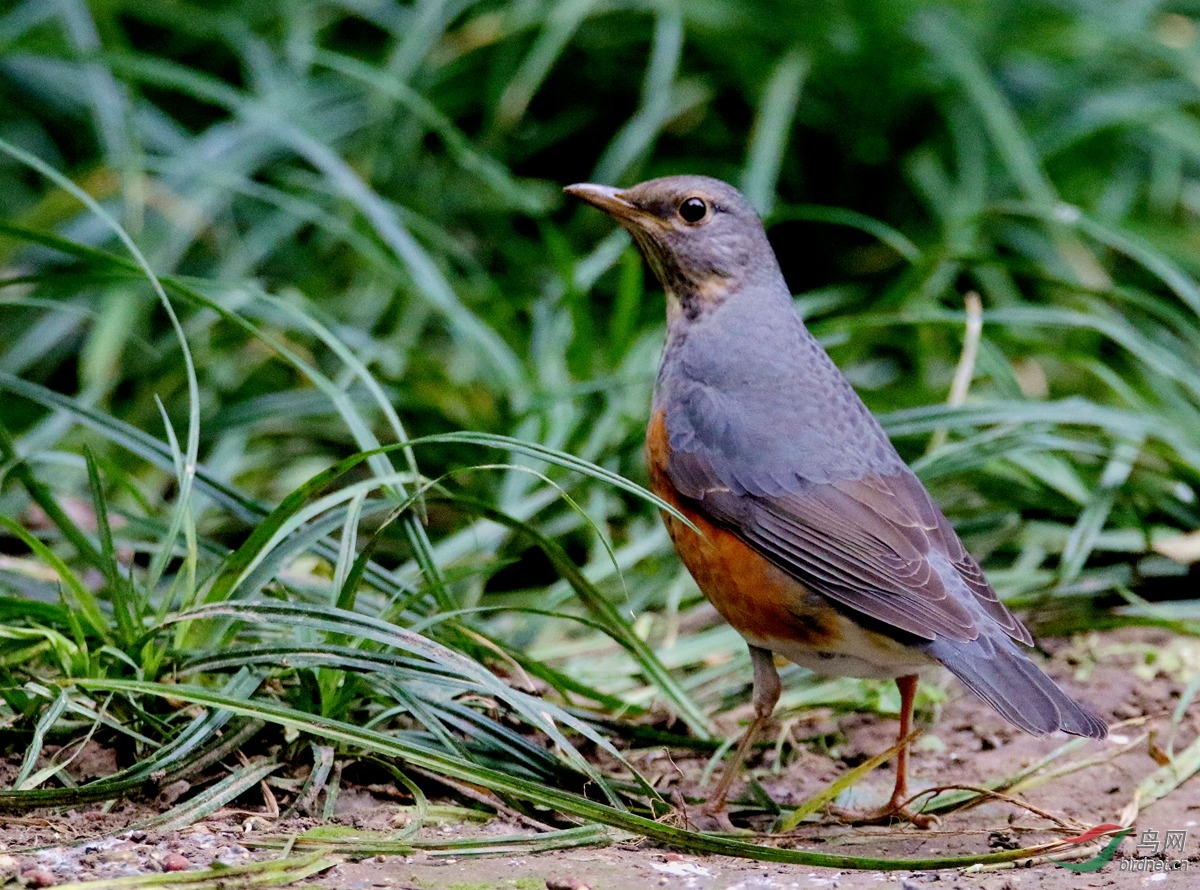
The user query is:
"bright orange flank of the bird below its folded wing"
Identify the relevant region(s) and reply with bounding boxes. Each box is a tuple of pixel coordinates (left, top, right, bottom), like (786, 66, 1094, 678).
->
(646, 411, 841, 649)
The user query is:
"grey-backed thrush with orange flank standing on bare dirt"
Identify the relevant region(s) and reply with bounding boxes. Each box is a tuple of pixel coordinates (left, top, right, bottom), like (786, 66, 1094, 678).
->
(564, 175, 1108, 828)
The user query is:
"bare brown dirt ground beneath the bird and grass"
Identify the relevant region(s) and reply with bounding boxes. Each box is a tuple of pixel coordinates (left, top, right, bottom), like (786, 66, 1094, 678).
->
(0, 630, 1200, 890)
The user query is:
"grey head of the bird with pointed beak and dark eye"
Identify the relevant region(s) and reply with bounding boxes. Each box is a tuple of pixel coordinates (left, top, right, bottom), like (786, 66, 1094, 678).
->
(564, 176, 779, 319)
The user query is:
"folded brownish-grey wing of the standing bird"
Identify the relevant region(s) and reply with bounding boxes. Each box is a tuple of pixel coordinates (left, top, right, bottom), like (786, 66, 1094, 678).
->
(667, 417, 1032, 644)
